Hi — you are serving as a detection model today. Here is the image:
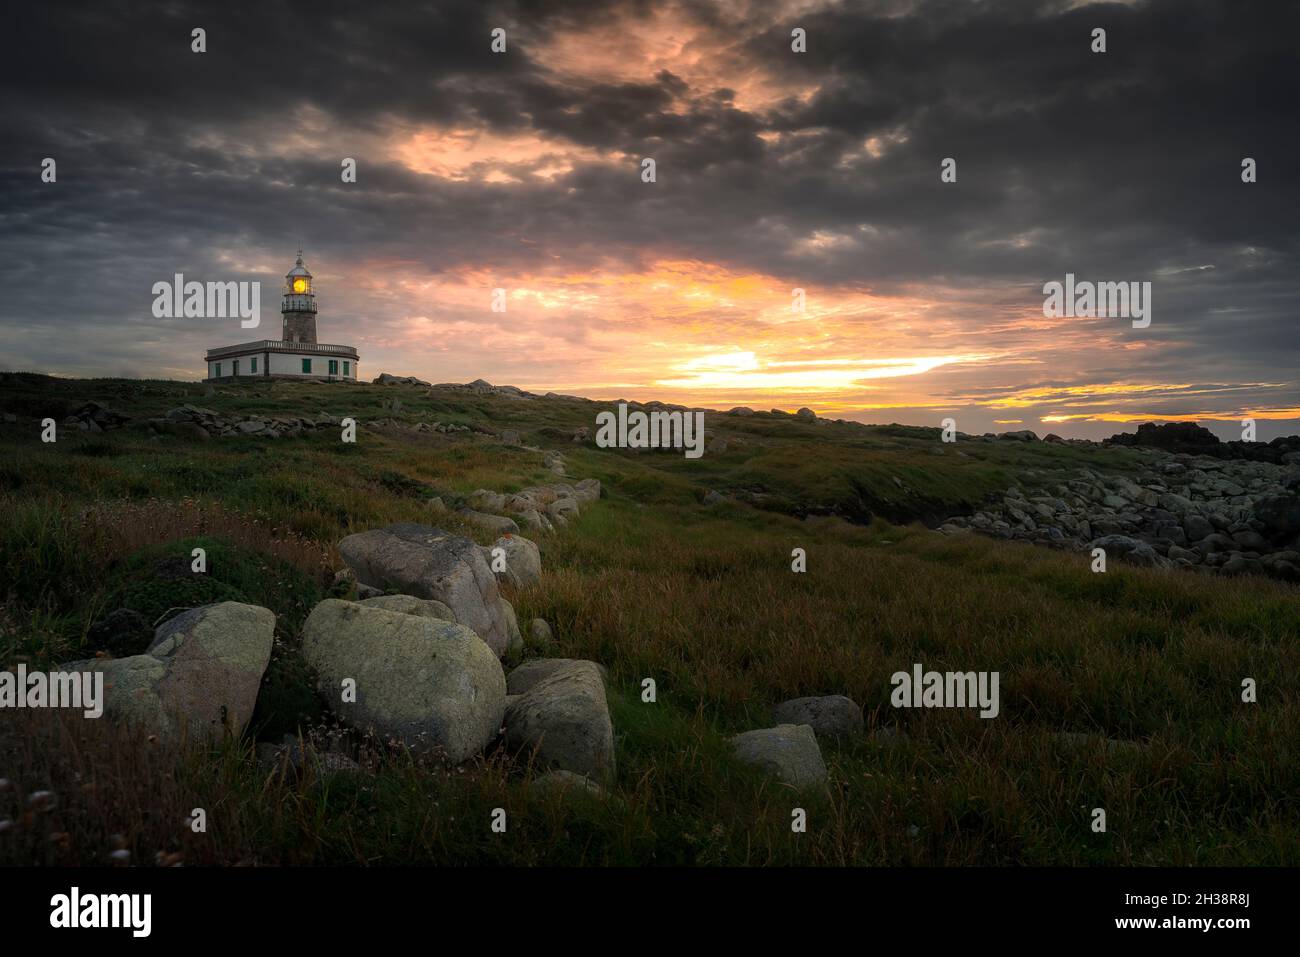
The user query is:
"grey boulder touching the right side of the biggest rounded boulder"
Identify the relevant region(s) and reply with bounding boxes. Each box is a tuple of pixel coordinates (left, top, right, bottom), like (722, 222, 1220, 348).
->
(506, 662, 615, 778)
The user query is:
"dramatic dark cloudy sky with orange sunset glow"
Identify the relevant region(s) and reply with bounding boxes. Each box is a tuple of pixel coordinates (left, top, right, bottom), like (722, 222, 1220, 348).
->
(0, 0, 1300, 438)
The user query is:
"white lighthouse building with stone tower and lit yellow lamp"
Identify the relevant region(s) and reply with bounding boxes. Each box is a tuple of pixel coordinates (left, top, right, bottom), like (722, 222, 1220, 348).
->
(204, 250, 358, 382)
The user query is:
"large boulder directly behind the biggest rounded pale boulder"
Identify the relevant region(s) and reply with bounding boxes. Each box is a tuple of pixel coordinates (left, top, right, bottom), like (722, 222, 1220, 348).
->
(338, 521, 510, 655)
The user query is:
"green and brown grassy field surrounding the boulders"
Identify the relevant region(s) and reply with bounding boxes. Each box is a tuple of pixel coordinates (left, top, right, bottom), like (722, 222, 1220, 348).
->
(0, 376, 1300, 865)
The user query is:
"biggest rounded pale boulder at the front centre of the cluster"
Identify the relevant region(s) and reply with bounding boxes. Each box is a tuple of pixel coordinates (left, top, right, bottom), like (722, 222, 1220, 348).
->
(303, 598, 506, 762)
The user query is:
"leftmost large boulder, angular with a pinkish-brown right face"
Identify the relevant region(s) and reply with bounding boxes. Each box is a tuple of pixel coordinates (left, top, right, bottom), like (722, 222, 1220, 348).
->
(66, 602, 276, 740)
